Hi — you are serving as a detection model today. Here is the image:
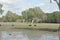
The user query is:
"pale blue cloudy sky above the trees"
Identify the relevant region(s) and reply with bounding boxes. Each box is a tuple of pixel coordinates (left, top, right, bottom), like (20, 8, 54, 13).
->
(0, 0, 58, 15)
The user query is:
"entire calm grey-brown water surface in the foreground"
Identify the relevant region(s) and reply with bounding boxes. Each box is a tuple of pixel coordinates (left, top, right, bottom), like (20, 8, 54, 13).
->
(0, 30, 59, 40)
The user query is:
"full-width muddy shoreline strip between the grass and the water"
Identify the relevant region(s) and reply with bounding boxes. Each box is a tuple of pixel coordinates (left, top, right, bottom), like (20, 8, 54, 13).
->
(0, 28, 60, 32)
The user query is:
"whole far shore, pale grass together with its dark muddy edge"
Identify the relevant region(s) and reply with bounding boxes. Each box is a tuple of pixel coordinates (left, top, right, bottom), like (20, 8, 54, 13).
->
(0, 22, 60, 32)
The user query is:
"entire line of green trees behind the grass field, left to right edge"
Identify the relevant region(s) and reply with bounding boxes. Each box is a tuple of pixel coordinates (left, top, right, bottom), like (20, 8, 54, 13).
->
(0, 7, 60, 23)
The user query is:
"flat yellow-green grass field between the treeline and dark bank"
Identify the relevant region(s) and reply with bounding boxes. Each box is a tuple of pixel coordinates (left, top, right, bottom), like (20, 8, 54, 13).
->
(0, 22, 60, 30)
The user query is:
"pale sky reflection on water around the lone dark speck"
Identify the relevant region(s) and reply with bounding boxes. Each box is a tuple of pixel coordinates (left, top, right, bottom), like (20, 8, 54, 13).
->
(2, 31, 29, 40)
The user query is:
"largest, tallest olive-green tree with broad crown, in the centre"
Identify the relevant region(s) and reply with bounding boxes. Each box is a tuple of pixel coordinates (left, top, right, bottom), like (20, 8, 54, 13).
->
(22, 7, 45, 22)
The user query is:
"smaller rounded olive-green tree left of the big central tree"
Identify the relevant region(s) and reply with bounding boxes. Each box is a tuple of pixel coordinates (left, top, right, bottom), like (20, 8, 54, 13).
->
(3, 11, 19, 22)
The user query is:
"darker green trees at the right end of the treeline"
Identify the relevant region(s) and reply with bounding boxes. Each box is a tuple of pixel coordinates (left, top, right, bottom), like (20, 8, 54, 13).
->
(47, 11, 60, 23)
